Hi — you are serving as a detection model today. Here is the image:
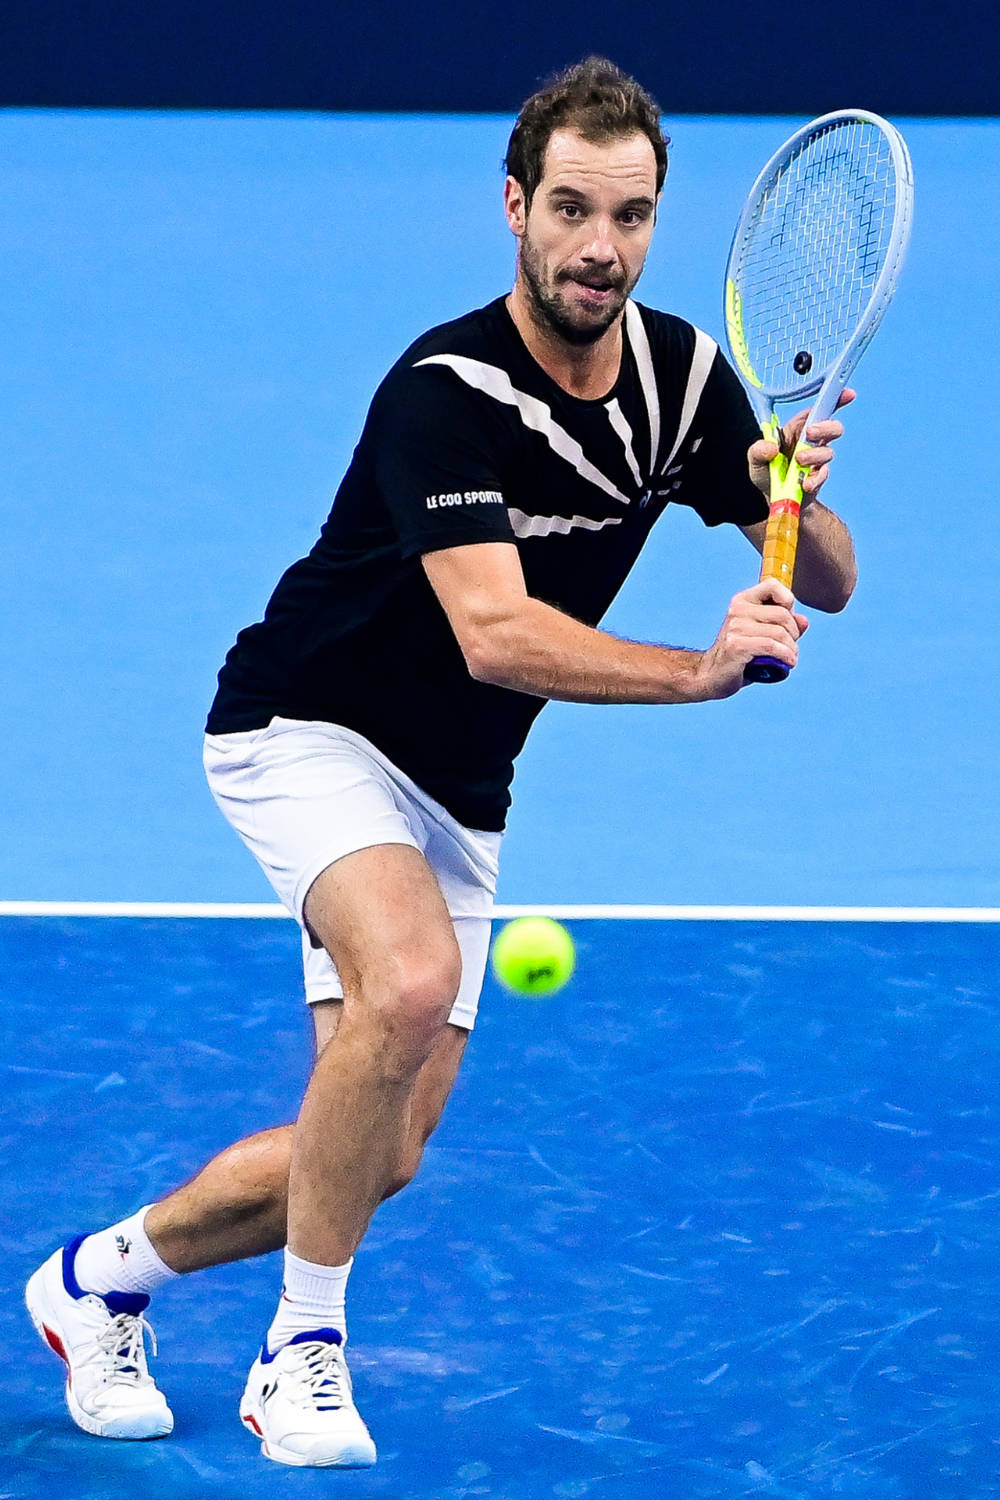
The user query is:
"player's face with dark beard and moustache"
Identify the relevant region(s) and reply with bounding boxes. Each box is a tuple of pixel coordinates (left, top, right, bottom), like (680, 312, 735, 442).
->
(505, 129, 657, 345)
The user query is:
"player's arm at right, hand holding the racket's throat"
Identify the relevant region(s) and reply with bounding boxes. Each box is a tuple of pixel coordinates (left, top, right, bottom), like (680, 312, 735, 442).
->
(742, 390, 858, 614)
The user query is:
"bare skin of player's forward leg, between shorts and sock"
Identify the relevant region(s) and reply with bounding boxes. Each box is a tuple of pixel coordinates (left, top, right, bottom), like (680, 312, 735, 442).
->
(288, 845, 462, 1266)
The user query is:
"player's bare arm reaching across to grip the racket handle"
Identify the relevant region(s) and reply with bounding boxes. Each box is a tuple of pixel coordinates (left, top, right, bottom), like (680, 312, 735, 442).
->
(423, 542, 807, 704)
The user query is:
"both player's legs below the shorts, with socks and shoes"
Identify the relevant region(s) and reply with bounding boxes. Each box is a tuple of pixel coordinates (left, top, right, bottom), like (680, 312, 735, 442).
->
(25, 846, 466, 1467)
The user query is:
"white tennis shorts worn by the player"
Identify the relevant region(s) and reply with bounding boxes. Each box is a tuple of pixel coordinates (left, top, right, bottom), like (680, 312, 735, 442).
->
(204, 719, 501, 1031)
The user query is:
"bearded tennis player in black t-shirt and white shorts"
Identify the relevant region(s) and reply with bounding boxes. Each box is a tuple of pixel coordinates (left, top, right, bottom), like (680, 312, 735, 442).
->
(27, 59, 855, 1467)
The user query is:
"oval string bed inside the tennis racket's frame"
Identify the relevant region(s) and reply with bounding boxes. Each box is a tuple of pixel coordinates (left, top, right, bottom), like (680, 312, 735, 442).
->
(735, 120, 897, 392)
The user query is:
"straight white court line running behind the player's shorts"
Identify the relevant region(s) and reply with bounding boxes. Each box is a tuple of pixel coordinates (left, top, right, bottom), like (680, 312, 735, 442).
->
(0, 902, 1000, 923)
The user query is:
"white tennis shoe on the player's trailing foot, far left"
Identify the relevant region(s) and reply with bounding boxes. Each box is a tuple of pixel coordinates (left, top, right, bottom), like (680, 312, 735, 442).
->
(24, 1235, 174, 1439)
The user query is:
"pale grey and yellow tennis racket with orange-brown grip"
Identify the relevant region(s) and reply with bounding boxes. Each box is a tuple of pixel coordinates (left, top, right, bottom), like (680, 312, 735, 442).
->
(726, 110, 913, 683)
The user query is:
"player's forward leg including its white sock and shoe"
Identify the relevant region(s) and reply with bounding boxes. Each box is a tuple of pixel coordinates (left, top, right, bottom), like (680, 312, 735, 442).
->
(240, 845, 462, 1467)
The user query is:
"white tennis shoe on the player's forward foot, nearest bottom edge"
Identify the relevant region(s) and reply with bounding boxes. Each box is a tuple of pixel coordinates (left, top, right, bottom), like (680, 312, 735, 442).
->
(240, 1328, 375, 1469)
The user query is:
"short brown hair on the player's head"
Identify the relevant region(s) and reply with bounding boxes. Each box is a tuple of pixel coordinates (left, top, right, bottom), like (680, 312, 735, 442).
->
(504, 57, 670, 206)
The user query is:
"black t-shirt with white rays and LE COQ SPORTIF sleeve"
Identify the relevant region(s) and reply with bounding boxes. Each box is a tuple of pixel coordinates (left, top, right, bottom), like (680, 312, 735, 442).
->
(207, 299, 768, 830)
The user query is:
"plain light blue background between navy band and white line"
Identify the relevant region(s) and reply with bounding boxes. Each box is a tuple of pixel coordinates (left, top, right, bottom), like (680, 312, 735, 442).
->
(0, 113, 1000, 905)
